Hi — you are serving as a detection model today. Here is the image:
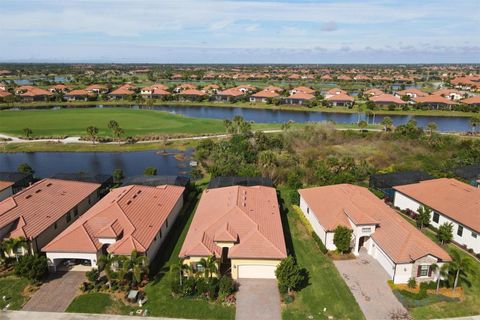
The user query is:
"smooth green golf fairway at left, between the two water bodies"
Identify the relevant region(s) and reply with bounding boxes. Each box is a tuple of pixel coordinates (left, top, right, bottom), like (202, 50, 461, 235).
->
(0, 108, 233, 137)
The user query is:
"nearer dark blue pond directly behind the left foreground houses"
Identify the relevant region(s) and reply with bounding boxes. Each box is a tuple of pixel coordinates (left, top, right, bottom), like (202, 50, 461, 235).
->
(0, 149, 193, 178)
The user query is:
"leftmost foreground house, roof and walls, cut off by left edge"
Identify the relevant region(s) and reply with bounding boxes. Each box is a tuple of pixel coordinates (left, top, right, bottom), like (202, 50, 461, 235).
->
(0, 179, 100, 253)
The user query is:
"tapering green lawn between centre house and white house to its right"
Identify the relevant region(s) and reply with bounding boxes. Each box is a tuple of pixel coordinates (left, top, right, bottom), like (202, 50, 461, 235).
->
(282, 188, 364, 319)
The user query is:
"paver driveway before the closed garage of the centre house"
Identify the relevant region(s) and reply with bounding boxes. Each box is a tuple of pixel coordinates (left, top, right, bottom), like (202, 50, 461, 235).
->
(235, 279, 281, 320)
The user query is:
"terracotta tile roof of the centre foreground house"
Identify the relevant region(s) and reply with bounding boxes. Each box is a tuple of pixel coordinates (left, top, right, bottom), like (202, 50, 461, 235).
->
(180, 186, 287, 259)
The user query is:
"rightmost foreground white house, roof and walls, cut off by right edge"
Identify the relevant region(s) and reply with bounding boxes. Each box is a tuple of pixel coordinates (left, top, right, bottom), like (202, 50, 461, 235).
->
(394, 178, 480, 253)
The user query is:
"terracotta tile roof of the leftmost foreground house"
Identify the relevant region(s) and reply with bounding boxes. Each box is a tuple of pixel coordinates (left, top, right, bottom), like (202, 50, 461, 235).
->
(0, 179, 100, 239)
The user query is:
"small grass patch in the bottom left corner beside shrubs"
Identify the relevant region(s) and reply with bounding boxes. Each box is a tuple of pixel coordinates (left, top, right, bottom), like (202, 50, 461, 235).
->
(0, 276, 28, 310)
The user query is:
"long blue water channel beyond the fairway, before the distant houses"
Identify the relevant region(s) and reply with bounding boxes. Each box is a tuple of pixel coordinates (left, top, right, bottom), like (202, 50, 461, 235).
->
(3, 104, 471, 132)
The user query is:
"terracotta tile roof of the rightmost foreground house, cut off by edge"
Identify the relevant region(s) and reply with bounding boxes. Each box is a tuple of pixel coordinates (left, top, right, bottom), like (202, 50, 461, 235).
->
(394, 178, 480, 233)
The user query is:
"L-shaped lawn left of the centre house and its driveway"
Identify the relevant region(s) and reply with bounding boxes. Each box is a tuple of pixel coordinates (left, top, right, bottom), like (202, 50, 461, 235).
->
(145, 191, 235, 319)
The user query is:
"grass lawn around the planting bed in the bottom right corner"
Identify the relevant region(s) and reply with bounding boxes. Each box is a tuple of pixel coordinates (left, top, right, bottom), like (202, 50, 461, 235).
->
(394, 214, 480, 319)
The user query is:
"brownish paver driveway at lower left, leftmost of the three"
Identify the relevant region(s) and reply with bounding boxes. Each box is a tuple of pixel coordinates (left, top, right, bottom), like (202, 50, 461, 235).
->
(22, 271, 85, 312)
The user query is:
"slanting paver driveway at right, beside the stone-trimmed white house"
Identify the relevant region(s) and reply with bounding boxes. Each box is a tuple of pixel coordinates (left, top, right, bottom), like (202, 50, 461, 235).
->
(334, 250, 407, 320)
